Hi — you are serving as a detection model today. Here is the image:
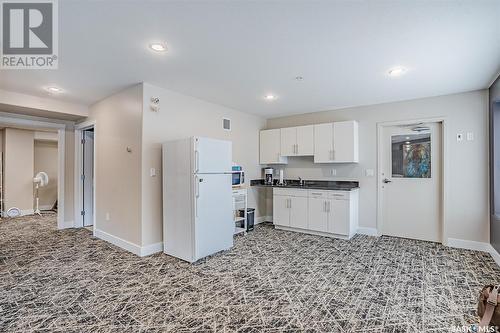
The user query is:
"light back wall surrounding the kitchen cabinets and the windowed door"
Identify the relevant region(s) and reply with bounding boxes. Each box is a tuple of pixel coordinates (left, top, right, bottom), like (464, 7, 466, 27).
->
(267, 90, 489, 242)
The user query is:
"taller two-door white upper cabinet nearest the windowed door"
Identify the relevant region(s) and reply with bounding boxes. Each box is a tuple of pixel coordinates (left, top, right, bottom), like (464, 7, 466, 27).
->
(314, 120, 359, 163)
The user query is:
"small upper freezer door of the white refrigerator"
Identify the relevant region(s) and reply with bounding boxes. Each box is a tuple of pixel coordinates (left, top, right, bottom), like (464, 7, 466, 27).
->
(193, 137, 233, 173)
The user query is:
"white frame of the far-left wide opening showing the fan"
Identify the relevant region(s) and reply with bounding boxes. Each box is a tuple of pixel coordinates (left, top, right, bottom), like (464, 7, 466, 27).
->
(0, 112, 66, 229)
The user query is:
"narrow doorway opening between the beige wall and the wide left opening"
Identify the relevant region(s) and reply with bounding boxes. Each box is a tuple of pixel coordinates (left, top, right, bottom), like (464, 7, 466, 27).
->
(75, 124, 95, 231)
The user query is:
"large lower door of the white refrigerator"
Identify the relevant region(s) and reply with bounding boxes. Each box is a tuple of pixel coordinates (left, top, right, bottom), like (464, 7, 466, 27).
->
(194, 174, 234, 260)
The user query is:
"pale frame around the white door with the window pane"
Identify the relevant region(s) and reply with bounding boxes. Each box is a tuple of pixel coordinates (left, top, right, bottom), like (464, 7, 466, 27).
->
(377, 117, 449, 245)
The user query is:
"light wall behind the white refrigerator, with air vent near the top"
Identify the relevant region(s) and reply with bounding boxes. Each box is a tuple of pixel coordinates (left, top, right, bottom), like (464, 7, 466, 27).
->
(142, 84, 265, 245)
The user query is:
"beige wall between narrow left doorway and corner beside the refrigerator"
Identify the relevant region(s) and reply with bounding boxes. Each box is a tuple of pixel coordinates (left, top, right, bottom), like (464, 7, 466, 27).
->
(89, 85, 142, 246)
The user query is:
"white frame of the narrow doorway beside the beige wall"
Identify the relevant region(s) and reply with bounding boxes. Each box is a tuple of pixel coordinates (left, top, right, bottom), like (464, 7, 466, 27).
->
(74, 120, 97, 231)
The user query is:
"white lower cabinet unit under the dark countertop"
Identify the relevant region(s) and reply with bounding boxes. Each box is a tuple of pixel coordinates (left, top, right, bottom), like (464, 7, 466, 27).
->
(273, 189, 358, 238)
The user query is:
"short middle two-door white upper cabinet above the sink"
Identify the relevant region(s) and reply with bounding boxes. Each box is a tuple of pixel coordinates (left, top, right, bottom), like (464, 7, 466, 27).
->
(281, 125, 314, 156)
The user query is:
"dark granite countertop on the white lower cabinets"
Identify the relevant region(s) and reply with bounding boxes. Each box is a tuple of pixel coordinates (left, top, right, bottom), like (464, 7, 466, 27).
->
(250, 179, 359, 191)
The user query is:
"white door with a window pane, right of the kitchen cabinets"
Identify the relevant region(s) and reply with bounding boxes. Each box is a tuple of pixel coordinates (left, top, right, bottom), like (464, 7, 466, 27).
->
(378, 123, 442, 242)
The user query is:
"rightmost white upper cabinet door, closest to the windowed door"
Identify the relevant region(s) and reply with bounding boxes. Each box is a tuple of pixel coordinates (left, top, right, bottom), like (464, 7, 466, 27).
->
(333, 121, 359, 162)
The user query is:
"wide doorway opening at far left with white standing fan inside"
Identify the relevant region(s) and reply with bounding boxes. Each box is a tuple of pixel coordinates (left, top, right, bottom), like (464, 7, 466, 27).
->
(0, 114, 66, 229)
